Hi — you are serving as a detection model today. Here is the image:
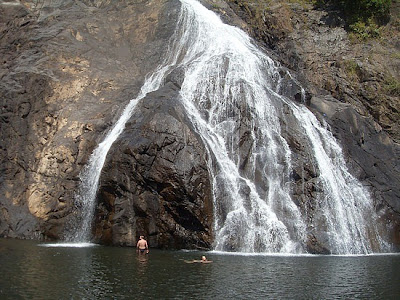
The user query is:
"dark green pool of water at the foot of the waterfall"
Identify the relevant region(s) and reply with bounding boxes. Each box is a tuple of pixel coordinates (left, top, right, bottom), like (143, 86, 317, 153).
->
(0, 239, 400, 299)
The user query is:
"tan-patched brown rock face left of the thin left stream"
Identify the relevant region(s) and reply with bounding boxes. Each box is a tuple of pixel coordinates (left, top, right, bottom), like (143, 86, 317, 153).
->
(0, 0, 183, 239)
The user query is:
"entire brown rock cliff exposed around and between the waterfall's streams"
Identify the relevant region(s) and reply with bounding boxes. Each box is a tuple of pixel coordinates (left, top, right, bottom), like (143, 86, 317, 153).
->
(0, 0, 400, 253)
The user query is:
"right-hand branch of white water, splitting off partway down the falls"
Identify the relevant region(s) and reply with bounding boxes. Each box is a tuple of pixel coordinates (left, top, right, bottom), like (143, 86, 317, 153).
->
(292, 106, 390, 254)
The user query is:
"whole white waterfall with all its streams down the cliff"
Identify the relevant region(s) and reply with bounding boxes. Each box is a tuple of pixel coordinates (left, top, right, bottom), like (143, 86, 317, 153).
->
(65, 0, 387, 254)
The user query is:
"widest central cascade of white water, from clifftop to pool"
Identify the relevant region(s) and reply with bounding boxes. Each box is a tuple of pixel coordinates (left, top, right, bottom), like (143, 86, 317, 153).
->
(179, 0, 306, 252)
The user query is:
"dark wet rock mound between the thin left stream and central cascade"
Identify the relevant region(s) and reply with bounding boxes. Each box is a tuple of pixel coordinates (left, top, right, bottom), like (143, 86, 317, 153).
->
(95, 83, 213, 249)
